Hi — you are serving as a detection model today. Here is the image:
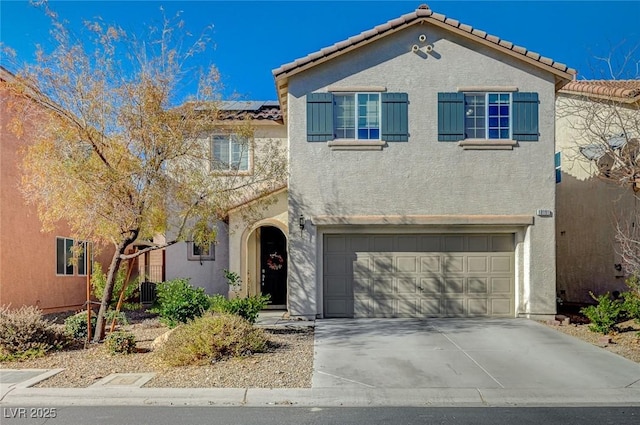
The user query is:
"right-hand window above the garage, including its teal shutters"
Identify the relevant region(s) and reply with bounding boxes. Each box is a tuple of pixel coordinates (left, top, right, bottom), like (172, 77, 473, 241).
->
(438, 91, 539, 146)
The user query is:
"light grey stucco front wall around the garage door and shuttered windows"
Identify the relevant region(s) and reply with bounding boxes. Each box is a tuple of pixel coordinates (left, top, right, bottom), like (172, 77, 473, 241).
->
(287, 25, 556, 316)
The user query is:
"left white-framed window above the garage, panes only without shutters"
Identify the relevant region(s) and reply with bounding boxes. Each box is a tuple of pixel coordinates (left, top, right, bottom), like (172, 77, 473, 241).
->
(333, 93, 381, 140)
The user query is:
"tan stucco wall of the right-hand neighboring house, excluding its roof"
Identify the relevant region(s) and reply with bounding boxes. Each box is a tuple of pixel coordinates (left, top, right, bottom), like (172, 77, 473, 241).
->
(556, 94, 638, 303)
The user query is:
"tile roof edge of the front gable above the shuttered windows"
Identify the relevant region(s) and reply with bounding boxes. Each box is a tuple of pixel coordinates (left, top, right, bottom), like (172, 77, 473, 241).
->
(272, 4, 576, 119)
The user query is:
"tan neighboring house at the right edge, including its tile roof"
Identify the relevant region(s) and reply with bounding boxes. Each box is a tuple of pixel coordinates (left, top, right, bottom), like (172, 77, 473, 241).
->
(556, 80, 640, 303)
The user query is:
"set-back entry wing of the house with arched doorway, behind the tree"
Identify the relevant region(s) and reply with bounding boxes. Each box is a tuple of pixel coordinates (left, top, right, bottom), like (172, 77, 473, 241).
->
(165, 101, 288, 308)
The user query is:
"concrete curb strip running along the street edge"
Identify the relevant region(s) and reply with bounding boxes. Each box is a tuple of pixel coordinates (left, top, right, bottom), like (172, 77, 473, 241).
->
(0, 387, 640, 407)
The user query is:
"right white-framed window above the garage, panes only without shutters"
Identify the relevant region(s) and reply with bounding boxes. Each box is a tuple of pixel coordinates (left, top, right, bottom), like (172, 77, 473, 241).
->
(464, 93, 511, 140)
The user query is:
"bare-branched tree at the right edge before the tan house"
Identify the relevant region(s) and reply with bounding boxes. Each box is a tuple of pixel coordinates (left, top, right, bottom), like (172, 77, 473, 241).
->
(556, 46, 640, 274)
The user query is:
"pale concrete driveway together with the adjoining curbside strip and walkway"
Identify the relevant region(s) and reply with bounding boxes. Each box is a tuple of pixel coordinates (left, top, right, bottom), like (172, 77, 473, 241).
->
(0, 312, 640, 407)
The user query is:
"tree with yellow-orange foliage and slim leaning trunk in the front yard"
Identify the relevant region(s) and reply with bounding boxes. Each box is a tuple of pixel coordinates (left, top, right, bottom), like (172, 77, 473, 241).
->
(4, 4, 286, 341)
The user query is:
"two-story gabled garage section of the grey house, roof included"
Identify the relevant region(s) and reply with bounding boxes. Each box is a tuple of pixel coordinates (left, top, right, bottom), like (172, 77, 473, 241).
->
(272, 6, 575, 318)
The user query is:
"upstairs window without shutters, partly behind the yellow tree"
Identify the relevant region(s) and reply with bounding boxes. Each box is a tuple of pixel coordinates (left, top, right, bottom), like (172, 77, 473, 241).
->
(211, 133, 250, 171)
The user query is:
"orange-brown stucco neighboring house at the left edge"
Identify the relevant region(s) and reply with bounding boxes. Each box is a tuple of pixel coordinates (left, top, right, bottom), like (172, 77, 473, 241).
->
(0, 67, 109, 312)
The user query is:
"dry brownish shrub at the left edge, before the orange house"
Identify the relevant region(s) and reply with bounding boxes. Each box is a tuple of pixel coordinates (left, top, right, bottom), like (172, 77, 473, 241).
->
(0, 306, 69, 360)
